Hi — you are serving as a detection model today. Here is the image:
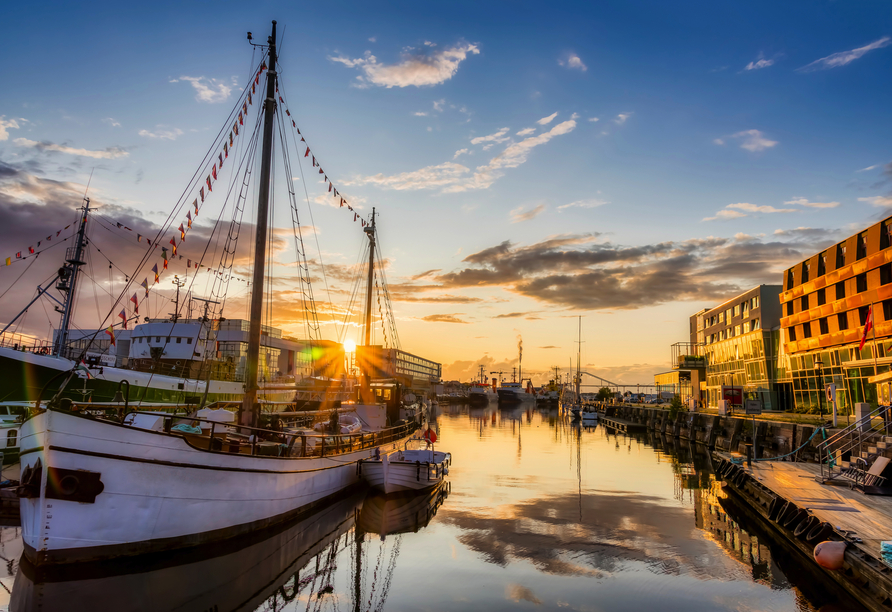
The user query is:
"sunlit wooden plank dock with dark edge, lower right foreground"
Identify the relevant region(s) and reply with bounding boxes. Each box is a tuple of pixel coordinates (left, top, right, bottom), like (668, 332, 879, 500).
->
(714, 452, 892, 610)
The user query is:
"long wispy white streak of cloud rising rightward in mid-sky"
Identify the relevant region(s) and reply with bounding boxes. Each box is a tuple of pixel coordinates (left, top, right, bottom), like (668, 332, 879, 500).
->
(343, 119, 576, 193)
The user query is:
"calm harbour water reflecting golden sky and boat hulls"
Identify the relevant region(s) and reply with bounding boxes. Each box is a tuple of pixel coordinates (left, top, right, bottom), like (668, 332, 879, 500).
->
(0, 406, 864, 612)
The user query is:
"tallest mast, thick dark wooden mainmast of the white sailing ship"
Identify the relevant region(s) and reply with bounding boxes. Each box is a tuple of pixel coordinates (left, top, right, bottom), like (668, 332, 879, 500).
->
(239, 21, 276, 425)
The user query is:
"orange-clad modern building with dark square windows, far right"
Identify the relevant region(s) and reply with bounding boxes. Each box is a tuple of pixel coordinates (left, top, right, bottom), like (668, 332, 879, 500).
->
(779, 217, 892, 411)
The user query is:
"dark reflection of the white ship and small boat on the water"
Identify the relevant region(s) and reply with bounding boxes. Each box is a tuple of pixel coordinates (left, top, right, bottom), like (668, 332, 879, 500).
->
(10, 483, 449, 612)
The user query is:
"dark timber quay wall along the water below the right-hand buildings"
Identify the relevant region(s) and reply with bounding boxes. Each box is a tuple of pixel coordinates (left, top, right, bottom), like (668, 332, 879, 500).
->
(598, 404, 834, 461)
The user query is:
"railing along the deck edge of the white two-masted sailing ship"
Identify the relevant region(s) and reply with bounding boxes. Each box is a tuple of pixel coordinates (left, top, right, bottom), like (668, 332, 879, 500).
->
(122, 410, 420, 458)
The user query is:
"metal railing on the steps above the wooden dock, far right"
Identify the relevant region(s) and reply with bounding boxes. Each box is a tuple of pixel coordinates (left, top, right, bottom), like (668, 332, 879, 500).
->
(816, 406, 892, 485)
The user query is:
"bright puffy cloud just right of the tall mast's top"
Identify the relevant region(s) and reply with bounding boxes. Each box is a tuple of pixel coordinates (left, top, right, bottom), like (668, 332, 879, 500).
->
(328, 43, 480, 89)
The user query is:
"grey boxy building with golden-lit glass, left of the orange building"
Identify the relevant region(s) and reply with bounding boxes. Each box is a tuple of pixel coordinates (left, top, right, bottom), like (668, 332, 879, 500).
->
(688, 285, 789, 410)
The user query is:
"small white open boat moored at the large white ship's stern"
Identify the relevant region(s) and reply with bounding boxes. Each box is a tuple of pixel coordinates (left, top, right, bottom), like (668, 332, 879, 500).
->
(359, 438, 452, 494)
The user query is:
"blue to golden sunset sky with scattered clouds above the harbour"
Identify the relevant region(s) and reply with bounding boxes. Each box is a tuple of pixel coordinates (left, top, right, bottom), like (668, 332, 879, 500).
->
(0, 1, 892, 384)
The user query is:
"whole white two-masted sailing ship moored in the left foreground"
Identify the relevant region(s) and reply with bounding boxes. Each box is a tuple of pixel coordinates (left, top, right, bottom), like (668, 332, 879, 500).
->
(17, 21, 418, 567)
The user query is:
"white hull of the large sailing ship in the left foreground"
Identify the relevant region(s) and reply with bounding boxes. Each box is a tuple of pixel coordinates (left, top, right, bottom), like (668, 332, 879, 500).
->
(20, 410, 408, 565)
